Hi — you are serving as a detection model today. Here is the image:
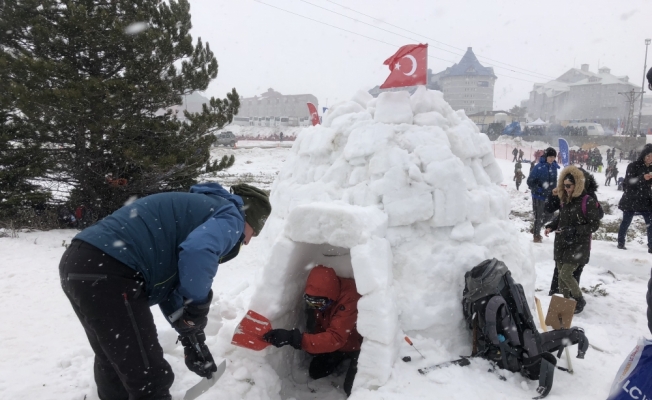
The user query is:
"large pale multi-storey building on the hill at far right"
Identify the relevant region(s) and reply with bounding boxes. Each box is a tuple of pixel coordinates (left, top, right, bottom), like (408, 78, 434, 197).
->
(527, 64, 640, 130)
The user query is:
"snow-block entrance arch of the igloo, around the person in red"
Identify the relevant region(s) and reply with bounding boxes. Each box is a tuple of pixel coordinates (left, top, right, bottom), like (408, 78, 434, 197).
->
(250, 203, 398, 394)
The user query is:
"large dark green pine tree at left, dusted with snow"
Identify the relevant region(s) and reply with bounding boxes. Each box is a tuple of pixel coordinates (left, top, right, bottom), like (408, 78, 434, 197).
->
(0, 0, 240, 217)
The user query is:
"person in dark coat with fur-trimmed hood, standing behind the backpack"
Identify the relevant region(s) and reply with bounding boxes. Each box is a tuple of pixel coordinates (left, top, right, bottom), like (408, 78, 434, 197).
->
(545, 165, 601, 314)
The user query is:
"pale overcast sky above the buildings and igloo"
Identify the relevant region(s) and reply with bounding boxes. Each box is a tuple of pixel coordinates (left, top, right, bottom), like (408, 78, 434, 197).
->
(190, 0, 652, 109)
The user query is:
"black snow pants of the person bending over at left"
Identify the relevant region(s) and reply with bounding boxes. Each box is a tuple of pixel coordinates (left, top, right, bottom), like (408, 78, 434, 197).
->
(59, 240, 174, 400)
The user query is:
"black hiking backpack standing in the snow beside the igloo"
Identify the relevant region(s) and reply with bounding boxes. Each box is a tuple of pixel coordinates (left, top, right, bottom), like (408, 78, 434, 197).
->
(462, 258, 589, 398)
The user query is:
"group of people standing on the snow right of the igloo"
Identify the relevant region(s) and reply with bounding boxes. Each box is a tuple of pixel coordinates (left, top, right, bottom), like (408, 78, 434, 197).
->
(514, 134, 652, 313)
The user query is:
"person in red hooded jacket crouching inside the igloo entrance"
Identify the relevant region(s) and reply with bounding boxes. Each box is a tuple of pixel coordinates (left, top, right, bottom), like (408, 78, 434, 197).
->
(264, 265, 362, 396)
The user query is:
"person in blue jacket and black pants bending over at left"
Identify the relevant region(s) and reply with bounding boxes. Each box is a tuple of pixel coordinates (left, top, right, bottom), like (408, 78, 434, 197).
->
(59, 183, 271, 400)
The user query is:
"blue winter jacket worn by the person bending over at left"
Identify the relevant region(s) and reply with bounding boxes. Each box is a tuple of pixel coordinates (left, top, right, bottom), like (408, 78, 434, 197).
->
(75, 183, 245, 322)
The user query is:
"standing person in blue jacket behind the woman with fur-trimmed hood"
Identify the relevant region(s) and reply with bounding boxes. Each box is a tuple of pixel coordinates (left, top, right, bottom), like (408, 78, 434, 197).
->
(527, 147, 559, 243)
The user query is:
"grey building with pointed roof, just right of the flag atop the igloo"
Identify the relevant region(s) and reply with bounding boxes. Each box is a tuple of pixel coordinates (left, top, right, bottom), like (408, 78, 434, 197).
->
(369, 47, 497, 115)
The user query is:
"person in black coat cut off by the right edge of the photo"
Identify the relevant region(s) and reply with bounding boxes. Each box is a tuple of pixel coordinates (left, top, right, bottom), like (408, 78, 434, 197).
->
(618, 144, 652, 253)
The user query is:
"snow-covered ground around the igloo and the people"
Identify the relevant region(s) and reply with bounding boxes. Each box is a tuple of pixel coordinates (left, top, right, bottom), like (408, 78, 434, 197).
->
(0, 147, 652, 400)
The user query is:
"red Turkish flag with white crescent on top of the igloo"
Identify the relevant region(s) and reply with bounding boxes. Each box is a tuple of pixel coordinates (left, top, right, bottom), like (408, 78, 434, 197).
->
(380, 44, 428, 89)
